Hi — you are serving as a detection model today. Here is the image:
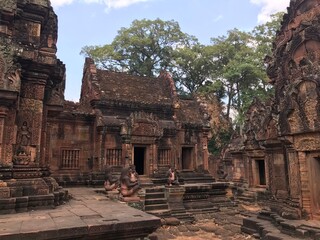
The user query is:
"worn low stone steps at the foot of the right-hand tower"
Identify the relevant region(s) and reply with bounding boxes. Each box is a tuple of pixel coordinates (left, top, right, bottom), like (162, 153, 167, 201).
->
(241, 211, 320, 240)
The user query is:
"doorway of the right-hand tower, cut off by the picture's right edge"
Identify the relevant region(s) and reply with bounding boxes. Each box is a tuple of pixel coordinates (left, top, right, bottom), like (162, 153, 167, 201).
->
(308, 157, 320, 216)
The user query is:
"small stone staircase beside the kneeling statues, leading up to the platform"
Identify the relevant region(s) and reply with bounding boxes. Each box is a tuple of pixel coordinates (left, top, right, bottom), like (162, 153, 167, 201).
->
(144, 187, 171, 218)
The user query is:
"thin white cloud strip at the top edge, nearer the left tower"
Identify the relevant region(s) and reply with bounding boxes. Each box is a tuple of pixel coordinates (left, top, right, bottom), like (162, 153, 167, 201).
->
(51, 0, 150, 10)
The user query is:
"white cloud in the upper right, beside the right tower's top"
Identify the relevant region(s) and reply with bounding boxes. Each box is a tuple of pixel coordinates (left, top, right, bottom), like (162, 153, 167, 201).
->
(250, 0, 290, 24)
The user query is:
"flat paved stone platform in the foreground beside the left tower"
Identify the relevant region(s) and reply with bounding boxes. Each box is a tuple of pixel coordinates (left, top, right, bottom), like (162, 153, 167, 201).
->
(0, 187, 161, 240)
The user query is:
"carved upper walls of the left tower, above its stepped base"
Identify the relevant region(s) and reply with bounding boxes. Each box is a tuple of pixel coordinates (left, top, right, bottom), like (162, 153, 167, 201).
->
(0, 0, 65, 166)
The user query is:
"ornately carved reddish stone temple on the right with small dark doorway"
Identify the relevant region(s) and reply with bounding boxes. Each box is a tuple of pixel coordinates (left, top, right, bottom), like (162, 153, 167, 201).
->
(230, 0, 320, 219)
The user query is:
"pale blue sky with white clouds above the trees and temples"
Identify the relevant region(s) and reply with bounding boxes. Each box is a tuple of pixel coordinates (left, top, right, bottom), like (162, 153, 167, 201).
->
(51, 0, 289, 101)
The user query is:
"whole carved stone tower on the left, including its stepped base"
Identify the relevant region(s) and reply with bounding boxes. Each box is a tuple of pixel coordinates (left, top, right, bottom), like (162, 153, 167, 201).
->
(0, 0, 65, 212)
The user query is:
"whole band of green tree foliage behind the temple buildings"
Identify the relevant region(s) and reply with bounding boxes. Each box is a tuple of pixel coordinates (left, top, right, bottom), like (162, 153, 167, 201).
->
(81, 13, 283, 153)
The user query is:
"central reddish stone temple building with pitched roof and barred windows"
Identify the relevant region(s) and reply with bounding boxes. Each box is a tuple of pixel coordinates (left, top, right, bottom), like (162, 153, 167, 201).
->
(45, 58, 210, 182)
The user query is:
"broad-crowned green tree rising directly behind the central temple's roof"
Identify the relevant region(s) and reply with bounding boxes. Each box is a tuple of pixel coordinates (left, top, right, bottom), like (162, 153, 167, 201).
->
(81, 19, 197, 77)
